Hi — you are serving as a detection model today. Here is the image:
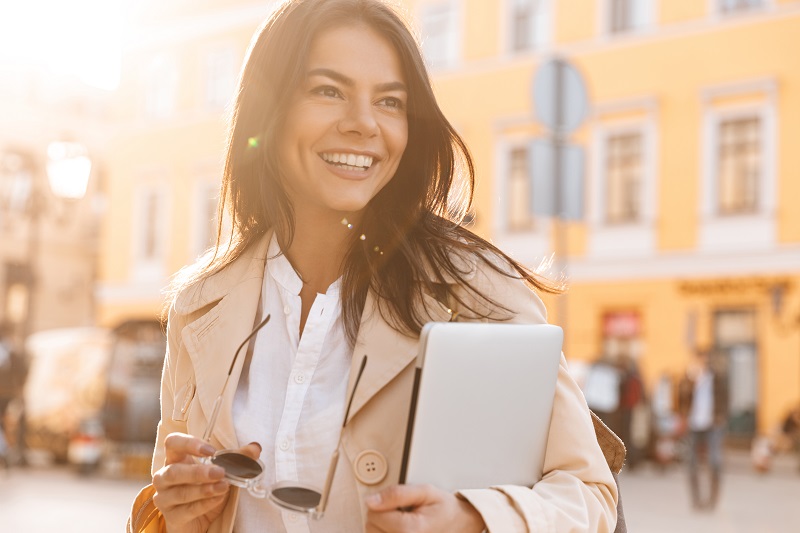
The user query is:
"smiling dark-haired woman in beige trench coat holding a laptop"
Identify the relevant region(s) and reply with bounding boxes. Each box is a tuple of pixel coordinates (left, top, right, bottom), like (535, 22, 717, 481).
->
(131, 0, 619, 533)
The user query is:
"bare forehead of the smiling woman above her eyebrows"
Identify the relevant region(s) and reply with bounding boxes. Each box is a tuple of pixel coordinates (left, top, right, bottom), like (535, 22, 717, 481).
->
(306, 24, 406, 84)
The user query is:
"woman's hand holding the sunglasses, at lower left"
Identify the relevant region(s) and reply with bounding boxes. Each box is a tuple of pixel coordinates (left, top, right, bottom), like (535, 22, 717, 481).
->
(153, 433, 261, 533)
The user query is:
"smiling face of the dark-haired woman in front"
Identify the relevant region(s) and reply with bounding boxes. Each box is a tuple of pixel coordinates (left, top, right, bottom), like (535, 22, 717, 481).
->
(277, 25, 408, 219)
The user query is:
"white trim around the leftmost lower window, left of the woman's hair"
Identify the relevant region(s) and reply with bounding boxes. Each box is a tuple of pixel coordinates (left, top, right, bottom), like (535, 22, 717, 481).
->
(131, 182, 171, 282)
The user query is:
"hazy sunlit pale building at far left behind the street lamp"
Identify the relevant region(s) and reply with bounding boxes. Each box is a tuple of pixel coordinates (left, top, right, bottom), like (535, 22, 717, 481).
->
(0, 64, 109, 350)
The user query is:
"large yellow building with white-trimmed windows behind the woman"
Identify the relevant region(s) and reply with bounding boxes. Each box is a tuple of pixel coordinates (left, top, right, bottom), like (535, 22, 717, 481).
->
(99, 0, 800, 438)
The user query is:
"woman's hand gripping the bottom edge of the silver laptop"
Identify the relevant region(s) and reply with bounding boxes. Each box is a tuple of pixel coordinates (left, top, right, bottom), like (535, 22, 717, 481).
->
(366, 485, 486, 533)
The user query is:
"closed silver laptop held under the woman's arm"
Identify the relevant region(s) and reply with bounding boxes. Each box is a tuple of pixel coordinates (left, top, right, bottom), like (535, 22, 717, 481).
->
(400, 322, 563, 491)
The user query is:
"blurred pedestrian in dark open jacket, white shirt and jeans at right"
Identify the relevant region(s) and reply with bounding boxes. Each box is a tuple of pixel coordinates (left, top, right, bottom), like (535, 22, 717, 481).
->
(678, 350, 728, 510)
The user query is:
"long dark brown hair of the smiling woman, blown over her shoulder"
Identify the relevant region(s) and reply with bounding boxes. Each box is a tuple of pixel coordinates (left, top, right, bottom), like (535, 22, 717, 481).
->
(174, 0, 558, 343)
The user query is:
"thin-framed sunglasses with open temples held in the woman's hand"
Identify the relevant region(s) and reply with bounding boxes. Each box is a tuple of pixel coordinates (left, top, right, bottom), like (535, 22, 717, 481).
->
(200, 315, 367, 520)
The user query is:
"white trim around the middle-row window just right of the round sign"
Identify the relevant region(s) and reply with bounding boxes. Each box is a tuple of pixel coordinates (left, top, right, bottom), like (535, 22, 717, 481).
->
(586, 101, 658, 257)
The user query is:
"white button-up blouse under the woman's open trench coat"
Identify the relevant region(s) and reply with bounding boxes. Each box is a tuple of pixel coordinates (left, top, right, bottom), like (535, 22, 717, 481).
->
(233, 237, 362, 533)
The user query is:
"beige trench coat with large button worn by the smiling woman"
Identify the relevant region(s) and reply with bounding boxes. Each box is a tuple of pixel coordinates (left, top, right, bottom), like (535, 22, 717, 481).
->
(152, 237, 624, 533)
